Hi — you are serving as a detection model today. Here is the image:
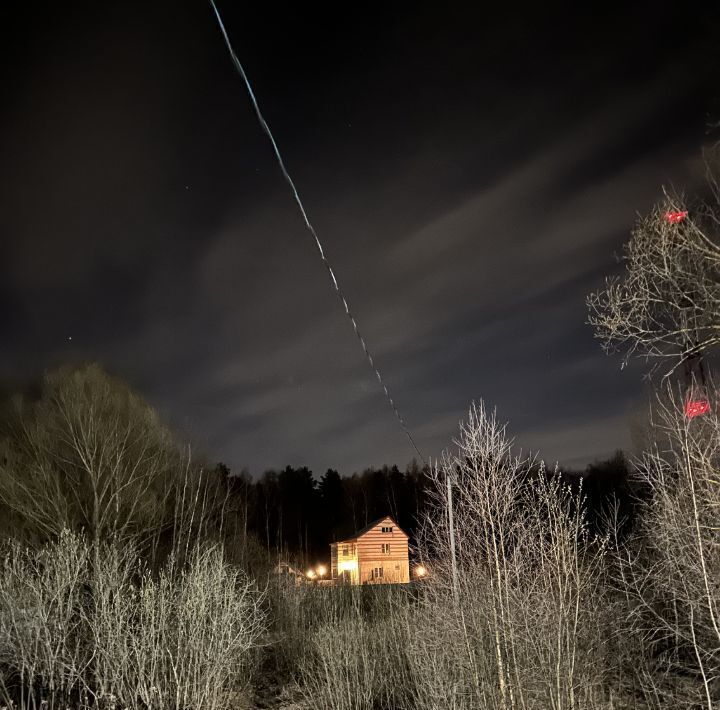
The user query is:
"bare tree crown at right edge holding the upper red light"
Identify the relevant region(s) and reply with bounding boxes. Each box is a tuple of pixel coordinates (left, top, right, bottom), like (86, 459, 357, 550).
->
(587, 154, 720, 372)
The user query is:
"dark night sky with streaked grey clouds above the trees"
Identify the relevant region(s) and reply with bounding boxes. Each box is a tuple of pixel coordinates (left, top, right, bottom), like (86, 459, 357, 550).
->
(0, 0, 720, 473)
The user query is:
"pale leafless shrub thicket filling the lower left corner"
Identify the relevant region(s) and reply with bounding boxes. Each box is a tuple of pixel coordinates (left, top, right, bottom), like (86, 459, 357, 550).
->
(0, 532, 264, 710)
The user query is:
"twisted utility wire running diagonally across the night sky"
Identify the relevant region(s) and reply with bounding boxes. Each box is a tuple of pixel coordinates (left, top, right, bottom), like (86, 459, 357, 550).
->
(210, 0, 425, 464)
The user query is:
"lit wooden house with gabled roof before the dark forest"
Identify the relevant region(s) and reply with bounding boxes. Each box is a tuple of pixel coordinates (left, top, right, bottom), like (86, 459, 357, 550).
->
(330, 516, 410, 584)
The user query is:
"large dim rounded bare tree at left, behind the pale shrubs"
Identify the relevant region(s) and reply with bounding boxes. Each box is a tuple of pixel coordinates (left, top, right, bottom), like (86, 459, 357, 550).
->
(0, 365, 186, 544)
